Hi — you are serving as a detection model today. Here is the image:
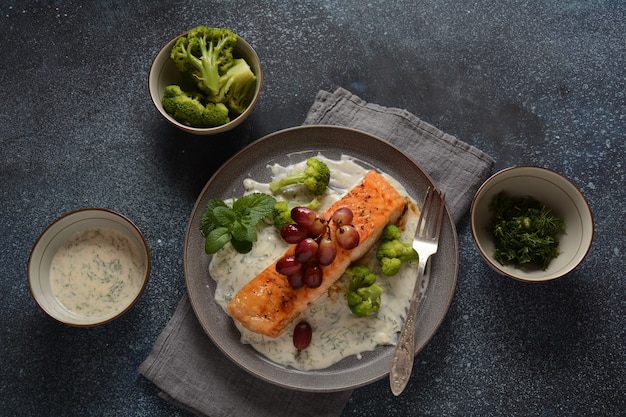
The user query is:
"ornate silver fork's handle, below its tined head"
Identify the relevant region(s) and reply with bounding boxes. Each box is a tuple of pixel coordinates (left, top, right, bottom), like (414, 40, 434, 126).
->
(389, 255, 428, 396)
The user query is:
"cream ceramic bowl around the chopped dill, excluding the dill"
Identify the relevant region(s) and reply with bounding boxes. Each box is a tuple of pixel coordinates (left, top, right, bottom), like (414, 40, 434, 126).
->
(470, 166, 594, 282)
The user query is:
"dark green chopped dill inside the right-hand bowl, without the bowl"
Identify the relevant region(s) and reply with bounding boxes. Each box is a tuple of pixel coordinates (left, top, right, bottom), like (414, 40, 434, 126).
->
(488, 192, 565, 270)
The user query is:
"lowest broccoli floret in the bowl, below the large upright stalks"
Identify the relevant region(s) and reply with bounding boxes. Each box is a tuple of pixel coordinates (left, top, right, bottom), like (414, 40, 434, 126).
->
(161, 85, 230, 127)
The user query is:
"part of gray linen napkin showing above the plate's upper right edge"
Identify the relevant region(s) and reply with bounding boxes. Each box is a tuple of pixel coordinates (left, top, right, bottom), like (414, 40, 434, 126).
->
(304, 88, 494, 222)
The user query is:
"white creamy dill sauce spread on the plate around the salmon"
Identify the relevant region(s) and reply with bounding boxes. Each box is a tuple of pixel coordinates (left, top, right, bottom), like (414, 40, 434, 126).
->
(210, 155, 428, 370)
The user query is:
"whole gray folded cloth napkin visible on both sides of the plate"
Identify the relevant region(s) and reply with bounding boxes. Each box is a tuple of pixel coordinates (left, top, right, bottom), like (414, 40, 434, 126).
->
(139, 88, 494, 417)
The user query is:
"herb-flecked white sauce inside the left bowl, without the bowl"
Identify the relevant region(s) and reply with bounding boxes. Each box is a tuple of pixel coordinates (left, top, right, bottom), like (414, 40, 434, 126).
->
(50, 228, 145, 317)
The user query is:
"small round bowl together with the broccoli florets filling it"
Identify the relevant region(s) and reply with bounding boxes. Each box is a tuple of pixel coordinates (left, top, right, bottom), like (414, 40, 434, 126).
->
(148, 26, 263, 135)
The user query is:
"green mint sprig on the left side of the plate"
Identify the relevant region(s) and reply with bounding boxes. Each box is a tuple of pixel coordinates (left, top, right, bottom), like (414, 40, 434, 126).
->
(200, 193, 276, 255)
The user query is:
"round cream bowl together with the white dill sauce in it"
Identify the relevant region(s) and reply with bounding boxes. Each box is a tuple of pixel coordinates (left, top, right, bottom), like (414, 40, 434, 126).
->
(28, 208, 150, 327)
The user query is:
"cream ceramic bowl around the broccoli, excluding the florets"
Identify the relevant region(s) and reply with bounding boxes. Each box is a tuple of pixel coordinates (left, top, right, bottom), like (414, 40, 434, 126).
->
(148, 32, 263, 135)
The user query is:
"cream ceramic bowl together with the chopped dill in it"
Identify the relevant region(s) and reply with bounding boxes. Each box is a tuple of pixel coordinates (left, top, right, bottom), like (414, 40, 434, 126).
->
(470, 166, 594, 282)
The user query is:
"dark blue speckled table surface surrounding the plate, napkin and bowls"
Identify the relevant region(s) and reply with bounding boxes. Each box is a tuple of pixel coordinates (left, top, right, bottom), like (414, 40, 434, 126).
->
(0, 0, 626, 417)
